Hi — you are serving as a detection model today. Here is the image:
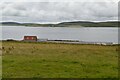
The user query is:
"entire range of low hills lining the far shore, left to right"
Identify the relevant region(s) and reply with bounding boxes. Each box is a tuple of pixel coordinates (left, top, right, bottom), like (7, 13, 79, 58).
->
(0, 21, 119, 27)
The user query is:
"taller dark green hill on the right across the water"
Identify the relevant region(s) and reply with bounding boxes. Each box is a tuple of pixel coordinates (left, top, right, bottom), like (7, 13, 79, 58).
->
(56, 21, 118, 27)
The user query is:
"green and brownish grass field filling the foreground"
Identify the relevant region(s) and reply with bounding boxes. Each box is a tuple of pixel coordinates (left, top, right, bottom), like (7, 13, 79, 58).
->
(2, 42, 118, 78)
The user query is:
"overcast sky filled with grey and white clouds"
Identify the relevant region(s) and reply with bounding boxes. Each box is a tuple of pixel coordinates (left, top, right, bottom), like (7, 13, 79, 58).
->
(0, 0, 118, 23)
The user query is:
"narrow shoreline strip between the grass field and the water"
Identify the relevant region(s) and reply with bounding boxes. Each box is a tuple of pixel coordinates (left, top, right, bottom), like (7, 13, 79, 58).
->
(0, 40, 119, 46)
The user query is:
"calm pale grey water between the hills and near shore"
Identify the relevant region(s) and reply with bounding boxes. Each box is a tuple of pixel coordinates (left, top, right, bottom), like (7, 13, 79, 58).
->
(0, 26, 118, 43)
